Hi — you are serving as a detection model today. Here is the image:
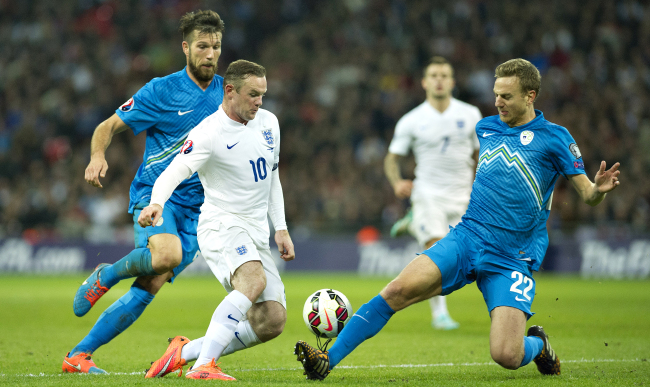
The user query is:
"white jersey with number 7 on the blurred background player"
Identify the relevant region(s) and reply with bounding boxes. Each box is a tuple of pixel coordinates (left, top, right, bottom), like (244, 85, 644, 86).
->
(388, 98, 481, 203)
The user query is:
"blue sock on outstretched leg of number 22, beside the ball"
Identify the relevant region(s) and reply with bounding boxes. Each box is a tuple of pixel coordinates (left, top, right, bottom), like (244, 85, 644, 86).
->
(328, 295, 395, 370)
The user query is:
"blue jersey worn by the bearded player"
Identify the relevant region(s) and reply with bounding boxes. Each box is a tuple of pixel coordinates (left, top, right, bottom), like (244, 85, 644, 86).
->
(116, 69, 223, 219)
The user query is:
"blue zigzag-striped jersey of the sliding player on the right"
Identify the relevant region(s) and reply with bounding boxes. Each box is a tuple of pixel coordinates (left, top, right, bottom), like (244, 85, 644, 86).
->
(457, 110, 585, 270)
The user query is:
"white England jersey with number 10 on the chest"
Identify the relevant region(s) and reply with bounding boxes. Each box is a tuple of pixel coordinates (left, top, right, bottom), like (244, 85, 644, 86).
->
(177, 107, 280, 247)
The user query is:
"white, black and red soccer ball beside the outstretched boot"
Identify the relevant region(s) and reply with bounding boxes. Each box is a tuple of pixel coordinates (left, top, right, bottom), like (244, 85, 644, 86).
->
(302, 289, 354, 339)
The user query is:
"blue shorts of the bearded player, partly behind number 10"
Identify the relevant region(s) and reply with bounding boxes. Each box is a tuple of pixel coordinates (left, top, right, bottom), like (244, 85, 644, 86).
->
(133, 202, 199, 282)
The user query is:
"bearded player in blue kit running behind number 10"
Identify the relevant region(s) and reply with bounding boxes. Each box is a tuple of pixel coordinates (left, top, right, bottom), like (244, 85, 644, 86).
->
(62, 10, 224, 373)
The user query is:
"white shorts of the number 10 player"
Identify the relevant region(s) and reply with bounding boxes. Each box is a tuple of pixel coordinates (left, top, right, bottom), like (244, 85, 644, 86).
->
(197, 224, 287, 309)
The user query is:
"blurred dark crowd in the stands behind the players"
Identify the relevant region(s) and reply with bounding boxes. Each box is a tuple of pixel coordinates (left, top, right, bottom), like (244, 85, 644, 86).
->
(0, 0, 650, 242)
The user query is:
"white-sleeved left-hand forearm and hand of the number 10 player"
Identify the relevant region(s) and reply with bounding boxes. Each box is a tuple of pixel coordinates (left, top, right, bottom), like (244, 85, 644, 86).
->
(138, 158, 192, 227)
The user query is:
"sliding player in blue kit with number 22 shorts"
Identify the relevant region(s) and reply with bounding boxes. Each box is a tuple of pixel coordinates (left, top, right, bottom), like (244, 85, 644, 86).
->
(294, 59, 620, 379)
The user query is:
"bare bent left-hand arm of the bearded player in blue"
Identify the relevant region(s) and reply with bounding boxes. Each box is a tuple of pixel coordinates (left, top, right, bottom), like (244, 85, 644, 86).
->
(85, 114, 128, 188)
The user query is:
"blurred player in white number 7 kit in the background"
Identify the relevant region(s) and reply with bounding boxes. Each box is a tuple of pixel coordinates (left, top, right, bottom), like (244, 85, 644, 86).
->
(384, 56, 482, 330)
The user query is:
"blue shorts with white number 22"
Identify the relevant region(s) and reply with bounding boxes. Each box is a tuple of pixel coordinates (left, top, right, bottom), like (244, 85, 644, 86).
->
(423, 229, 535, 318)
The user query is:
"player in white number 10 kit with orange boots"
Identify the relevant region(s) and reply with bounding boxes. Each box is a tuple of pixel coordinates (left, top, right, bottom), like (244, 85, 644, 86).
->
(138, 60, 295, 380)
